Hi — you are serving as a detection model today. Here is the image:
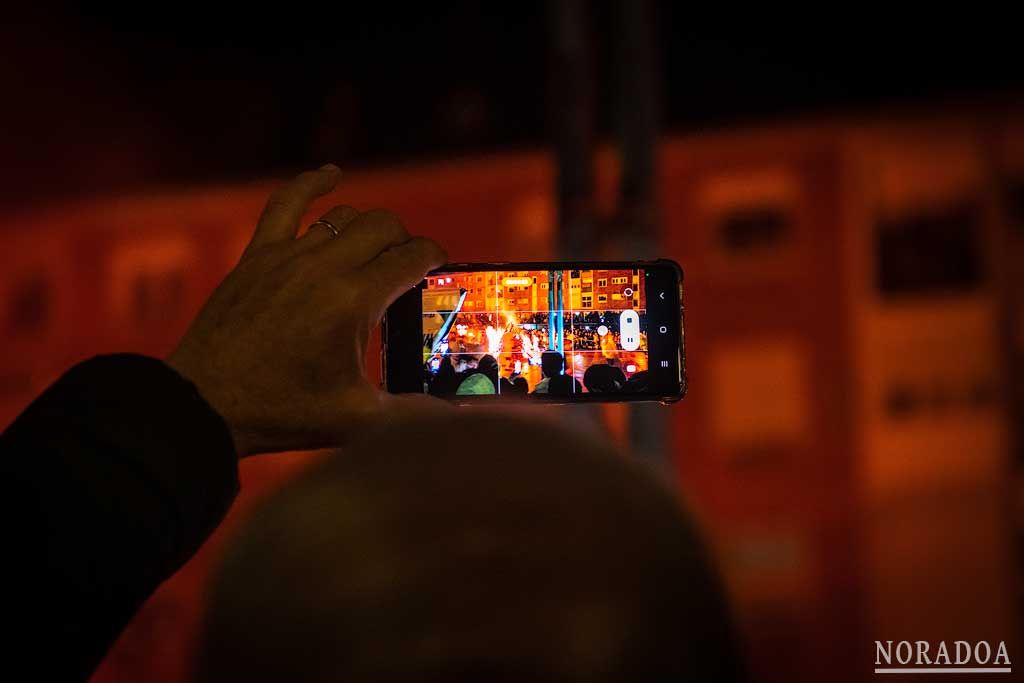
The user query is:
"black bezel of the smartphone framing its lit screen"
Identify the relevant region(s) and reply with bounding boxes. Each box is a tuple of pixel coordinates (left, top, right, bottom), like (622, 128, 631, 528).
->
(381, 259, 687, 405)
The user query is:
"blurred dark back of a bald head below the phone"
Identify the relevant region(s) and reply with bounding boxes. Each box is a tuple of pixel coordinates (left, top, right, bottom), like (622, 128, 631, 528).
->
(198, 411, 737, 682)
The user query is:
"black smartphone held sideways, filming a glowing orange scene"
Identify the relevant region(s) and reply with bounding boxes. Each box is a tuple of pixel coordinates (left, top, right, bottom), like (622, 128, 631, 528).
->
(381, 259, 686, 404)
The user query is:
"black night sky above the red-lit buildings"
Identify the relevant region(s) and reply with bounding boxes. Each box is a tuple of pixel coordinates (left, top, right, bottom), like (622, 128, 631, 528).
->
(0, 2, 1024, 205)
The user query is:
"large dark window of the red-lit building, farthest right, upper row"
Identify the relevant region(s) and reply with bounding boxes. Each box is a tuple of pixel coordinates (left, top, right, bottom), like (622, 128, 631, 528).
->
(874, 202, 984, 295)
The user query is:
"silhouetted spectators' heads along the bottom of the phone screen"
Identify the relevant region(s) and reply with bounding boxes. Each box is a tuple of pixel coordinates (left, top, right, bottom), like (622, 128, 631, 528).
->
(428, 350, 648, 396)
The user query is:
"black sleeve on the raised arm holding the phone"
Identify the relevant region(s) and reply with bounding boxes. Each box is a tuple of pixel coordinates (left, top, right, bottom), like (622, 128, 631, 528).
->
(0, 354, 239, 681)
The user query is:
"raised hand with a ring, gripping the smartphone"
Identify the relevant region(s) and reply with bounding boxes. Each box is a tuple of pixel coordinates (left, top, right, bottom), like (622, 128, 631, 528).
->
(167, 165, 445, 457)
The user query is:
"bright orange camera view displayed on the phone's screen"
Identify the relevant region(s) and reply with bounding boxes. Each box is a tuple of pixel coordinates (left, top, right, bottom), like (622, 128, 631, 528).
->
(423, 268, 648, 396)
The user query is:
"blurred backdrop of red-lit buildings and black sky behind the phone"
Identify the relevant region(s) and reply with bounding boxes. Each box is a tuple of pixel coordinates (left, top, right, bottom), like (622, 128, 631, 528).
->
(0, 0, 1024, 683)
